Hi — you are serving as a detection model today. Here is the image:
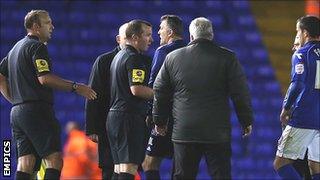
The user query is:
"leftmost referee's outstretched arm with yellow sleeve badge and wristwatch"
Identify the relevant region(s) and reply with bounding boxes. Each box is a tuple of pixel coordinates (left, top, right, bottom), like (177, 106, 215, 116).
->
(32, 43, 97, 99)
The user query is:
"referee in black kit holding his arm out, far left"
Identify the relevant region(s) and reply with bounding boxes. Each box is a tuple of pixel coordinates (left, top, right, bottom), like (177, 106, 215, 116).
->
(0, 10, 96, 179)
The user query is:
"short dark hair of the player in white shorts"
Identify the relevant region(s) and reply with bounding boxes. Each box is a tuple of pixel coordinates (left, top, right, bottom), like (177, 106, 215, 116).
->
(297, 15, 320, 38)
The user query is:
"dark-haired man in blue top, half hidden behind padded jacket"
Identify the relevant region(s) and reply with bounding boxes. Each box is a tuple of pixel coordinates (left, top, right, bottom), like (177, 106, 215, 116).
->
(142, 15, 186, 180)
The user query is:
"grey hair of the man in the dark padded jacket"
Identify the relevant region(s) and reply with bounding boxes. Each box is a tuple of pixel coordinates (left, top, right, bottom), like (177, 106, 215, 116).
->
(189, 17, 213, 40)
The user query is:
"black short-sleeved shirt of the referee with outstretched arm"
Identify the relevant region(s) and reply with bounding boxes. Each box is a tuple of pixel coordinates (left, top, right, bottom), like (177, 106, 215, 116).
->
(0, 36, 53, 105)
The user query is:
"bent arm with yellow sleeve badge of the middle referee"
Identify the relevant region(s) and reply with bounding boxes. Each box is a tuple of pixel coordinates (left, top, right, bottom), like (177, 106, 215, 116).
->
(126, 56, 153, 99)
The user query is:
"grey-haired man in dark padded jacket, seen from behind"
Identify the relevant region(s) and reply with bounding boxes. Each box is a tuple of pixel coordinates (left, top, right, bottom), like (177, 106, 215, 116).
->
(153, 17, 253, 179)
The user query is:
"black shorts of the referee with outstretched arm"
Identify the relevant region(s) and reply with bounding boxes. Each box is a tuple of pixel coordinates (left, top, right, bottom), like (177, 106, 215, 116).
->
(10, 102, 61, 158)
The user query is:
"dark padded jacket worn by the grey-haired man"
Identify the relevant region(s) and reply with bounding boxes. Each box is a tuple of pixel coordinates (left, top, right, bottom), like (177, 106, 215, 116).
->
(153, 39, 253, 143)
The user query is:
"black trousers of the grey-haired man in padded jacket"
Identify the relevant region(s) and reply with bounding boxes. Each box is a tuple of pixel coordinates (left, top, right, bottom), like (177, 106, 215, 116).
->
(173, 142, 231, 180)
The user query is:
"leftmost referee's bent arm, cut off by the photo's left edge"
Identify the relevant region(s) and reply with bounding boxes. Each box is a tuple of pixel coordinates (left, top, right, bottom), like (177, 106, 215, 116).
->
(0, 57, 12, 103)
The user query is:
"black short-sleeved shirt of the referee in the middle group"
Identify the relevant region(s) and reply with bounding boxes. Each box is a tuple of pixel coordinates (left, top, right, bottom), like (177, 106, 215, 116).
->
(110, 45, 151, 115)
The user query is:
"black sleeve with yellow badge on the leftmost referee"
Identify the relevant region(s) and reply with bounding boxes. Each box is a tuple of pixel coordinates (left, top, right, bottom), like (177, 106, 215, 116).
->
(32, 44, 51, 76)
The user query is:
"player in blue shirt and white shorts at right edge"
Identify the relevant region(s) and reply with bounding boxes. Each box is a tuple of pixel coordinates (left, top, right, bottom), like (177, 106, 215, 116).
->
(274, 16, 320, 179)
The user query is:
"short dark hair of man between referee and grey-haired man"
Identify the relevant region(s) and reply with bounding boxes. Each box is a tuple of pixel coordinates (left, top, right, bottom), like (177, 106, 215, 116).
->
(160, 14, 183, 36)
